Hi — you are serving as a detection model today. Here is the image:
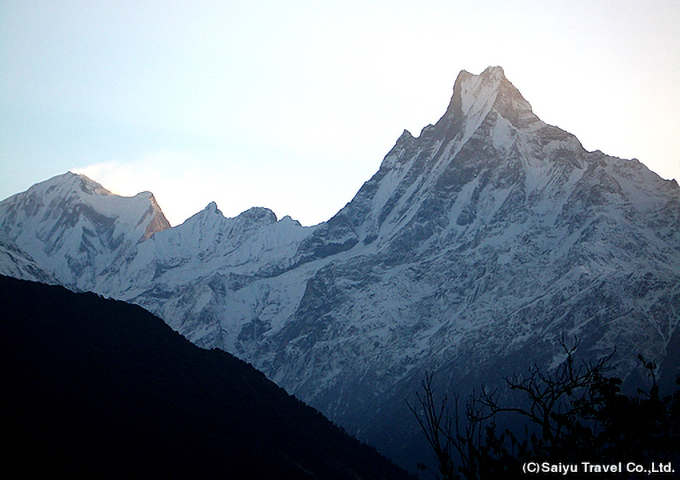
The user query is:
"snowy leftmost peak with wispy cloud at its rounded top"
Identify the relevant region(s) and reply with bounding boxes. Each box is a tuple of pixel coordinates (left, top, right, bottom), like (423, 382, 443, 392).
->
(0, 172, 170, 289)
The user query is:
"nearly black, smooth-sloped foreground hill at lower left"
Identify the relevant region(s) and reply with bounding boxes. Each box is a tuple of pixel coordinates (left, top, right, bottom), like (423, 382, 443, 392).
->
(0, 276, 407, 479)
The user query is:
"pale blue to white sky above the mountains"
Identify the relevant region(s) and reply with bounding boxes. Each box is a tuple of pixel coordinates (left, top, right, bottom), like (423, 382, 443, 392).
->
(0, 0, 680, 225)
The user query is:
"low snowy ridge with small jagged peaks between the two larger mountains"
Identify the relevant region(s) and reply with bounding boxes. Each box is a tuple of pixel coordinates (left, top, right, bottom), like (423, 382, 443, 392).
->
(97, 203, 314, 351)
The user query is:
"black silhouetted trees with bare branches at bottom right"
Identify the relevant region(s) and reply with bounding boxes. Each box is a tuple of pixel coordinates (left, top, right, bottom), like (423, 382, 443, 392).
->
(409, 339, 680, 480)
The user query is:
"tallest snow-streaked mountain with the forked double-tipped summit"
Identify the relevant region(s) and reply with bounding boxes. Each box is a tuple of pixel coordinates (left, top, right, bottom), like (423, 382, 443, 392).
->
(230, 68, 680, 458)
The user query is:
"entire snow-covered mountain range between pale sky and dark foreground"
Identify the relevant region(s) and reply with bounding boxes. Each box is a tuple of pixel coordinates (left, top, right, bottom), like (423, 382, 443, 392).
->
(0, 67, 680, 468)
